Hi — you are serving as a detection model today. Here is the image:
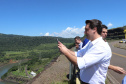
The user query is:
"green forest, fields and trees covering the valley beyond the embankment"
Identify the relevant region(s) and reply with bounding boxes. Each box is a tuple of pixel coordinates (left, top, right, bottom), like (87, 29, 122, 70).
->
(0, 34, 74, 83)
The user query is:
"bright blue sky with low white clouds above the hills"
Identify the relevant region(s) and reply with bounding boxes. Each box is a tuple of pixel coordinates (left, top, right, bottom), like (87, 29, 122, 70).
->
(0, 0, 126, 38)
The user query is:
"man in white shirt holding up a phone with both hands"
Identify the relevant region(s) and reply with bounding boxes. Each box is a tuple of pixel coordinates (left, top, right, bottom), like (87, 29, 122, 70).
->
(58, 19, 112, 84)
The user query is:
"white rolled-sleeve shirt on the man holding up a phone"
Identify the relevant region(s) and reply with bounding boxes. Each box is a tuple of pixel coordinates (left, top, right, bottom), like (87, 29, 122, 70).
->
(77, 37, 112, 84)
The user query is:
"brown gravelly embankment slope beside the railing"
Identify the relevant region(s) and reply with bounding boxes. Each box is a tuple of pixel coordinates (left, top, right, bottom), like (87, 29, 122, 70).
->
(27, 55, 70, 84)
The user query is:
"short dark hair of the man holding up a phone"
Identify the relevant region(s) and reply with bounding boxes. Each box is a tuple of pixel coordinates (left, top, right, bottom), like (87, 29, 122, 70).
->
(85, 19, 102, 35)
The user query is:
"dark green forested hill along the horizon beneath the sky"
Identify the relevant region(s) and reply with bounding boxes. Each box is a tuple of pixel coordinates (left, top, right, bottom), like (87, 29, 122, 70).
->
(0, 34, 74, 51)
